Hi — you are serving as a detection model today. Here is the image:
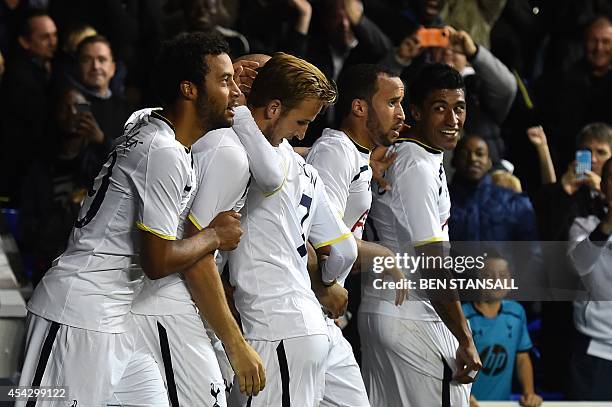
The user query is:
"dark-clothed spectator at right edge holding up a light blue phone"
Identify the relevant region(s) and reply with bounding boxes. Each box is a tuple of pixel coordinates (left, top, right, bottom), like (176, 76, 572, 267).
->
(532, 123, 612, 392)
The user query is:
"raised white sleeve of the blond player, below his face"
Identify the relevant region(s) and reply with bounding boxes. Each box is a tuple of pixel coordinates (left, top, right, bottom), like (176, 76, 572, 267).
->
(233, 106, 287, 196)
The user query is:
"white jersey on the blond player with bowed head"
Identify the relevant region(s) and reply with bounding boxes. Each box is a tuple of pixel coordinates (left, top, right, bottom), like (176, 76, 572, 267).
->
(229, 141, 352, 341)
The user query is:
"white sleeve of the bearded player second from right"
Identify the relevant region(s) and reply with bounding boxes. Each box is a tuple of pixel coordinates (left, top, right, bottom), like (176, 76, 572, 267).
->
(306, 143, 352, 218)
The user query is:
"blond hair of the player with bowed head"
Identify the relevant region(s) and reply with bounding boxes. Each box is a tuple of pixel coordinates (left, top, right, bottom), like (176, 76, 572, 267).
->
(248, 52, 338, 111)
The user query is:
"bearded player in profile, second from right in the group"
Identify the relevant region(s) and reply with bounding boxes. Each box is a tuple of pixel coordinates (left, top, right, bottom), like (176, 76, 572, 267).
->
(307, 64, 405, 407)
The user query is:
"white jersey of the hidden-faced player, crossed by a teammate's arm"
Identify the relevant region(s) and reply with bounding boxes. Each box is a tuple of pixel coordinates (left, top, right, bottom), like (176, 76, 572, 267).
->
(132, 128, 251, 315)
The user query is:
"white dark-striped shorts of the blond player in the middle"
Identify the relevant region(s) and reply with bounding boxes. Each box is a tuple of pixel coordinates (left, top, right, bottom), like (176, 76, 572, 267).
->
(228, 335, 329, 407)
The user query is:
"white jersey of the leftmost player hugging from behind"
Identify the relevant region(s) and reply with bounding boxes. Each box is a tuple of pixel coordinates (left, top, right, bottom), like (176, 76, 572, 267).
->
(28, 109, 196, 333)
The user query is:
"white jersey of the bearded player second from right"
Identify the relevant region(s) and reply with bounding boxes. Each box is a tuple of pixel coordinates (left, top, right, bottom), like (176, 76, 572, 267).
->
(306, 129, 372, 239)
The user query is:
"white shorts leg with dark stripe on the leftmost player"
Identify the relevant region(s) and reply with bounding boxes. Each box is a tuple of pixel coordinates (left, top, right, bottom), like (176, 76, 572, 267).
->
(16, 314, 133, 406)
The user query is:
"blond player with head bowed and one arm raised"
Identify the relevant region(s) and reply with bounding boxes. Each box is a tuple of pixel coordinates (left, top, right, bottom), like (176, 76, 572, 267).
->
(228, 53, 357, 407)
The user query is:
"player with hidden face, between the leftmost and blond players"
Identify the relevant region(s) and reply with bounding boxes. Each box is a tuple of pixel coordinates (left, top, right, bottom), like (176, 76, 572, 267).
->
(132, 55, 269, 407)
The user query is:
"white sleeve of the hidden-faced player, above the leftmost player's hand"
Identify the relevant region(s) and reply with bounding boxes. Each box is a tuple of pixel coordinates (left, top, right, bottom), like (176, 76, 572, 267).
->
(189, 146, 250, 230)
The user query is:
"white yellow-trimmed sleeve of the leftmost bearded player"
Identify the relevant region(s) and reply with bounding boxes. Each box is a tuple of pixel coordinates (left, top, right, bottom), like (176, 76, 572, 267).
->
(136, 148, 189, 240)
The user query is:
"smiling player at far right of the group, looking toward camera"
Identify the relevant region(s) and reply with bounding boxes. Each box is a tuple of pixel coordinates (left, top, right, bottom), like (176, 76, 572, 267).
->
(359, 64, 481, 407)
